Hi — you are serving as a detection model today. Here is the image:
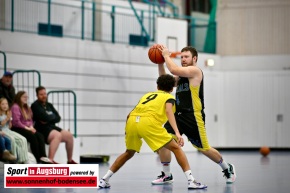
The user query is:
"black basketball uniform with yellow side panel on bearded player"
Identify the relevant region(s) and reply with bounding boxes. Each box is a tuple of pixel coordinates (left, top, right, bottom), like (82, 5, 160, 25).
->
(164, 71, 211, 151)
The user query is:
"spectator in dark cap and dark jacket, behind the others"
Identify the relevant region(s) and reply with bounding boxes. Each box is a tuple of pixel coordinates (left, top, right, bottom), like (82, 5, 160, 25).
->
(0, 71, 15, 107)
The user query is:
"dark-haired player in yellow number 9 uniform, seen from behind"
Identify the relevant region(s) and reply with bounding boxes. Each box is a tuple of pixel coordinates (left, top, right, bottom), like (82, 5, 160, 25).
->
(99, 75, 207, 189)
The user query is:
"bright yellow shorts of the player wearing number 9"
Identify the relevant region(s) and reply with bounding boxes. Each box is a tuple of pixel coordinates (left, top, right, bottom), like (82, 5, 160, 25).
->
(125, 116, 173, 152)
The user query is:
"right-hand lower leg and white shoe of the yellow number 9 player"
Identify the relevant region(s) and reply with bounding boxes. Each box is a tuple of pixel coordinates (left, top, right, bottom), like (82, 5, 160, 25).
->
(165, 140, 207, 189)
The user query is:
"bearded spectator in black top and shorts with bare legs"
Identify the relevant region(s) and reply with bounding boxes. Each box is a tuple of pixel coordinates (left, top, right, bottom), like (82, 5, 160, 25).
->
(31, 86, 76, 164)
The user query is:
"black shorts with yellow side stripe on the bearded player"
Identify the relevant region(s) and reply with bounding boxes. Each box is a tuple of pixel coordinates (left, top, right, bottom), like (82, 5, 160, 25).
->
(164, 111, 210, 151)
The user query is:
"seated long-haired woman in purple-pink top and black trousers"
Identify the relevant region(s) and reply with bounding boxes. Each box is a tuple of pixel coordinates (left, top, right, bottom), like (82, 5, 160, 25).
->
(11, 91, 52, 163)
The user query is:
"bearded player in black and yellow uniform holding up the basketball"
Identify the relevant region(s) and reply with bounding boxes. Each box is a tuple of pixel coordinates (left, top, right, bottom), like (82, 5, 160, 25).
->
(152, 46, 236, 184)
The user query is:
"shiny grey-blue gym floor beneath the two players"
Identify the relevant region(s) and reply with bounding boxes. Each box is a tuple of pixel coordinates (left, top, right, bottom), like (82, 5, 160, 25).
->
(0, 151, 290, 193)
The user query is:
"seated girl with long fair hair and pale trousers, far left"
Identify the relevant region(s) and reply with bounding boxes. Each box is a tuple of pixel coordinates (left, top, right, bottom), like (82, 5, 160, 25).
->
(0, 98, 28, 163)
